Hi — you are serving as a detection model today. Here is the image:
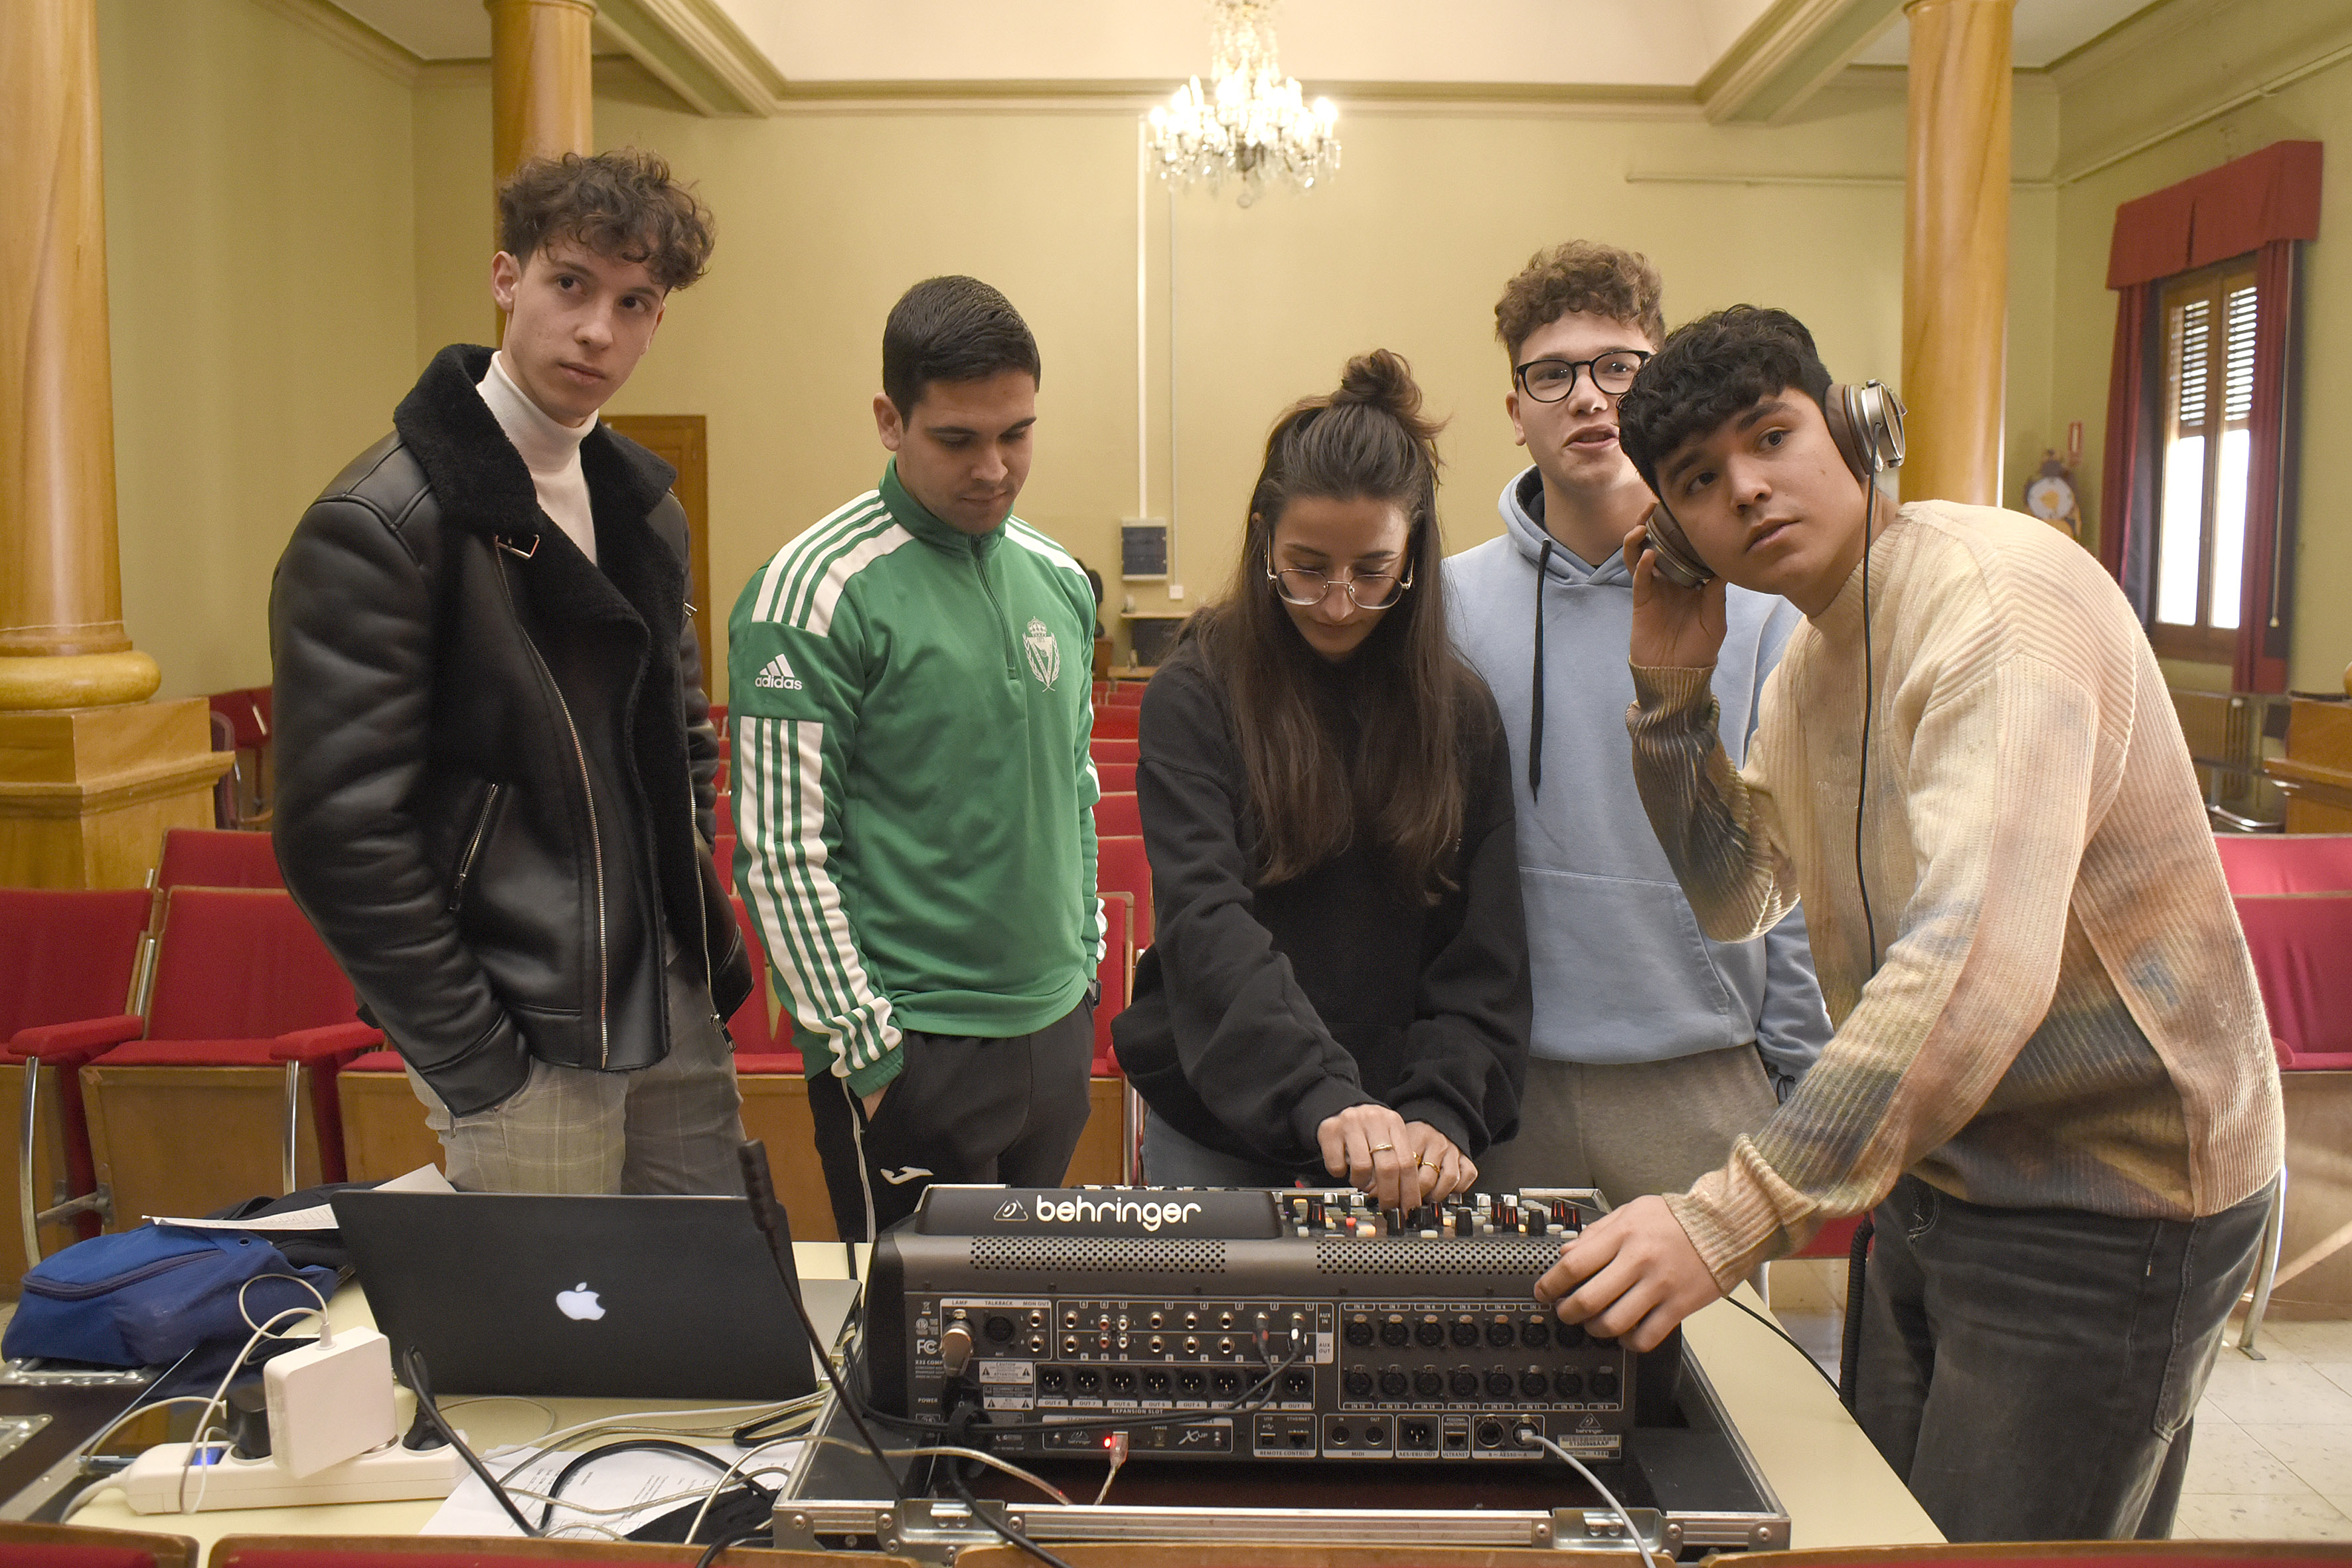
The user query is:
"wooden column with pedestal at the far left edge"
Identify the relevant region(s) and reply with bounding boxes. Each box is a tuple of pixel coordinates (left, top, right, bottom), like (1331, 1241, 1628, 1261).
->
(0, 0, 230, 886)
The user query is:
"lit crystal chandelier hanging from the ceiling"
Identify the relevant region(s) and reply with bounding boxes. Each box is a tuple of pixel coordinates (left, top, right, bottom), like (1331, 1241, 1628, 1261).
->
(1150, 0, 1338, 207)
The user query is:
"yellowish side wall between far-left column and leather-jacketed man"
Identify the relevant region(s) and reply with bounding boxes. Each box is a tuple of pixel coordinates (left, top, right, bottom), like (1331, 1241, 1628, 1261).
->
(99, 0, 416, 696)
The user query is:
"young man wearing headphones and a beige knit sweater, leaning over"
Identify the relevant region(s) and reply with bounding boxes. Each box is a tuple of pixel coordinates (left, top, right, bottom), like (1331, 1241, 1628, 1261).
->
(1536, 305, 2282, 1540)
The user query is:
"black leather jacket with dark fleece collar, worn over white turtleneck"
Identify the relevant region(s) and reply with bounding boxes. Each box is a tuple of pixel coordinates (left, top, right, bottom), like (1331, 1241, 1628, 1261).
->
(270, 346, 753, 1115)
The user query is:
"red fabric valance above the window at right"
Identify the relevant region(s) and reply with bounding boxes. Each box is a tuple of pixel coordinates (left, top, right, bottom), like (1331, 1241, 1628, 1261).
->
(2108, 141, 2321, 289)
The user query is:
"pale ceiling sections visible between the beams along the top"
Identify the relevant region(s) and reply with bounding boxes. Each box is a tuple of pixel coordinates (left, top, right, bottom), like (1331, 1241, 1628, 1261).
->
(334, 0, 2148, 87)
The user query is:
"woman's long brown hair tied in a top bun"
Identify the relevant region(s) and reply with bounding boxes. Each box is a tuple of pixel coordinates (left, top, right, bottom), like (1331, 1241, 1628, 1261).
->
(1186, 348, 1470, 903)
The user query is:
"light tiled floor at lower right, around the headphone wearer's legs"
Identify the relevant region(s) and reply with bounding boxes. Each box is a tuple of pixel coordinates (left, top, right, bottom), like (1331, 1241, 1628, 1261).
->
(1771, 1263, 2352, 1540)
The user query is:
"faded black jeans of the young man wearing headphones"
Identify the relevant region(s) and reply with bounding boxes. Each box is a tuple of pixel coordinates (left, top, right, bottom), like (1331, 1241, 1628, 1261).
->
(1855, 1176, 2270, 1540)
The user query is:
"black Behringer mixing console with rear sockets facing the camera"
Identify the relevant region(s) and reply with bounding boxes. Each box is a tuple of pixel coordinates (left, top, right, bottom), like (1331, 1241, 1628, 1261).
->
(866, 1187, 1634, 1462)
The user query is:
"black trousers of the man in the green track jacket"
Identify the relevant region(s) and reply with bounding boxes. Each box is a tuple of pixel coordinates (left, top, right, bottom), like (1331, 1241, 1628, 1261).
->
(809, 1002, 1093, 1241)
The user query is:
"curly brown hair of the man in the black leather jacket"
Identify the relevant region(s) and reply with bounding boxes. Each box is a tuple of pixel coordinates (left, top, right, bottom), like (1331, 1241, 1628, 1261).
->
(499, 148, 713, 289)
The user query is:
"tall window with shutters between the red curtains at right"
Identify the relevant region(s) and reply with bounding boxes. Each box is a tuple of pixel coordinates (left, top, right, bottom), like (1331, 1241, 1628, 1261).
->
(2148, 259, 2256, 663)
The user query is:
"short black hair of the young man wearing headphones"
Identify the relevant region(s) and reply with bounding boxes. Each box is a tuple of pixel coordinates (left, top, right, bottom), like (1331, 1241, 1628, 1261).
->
(1618, 305, 1830, 491)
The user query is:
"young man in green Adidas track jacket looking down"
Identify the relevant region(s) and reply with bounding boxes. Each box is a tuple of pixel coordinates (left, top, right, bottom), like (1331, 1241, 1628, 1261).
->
(727, 277, 1101, 1239)
